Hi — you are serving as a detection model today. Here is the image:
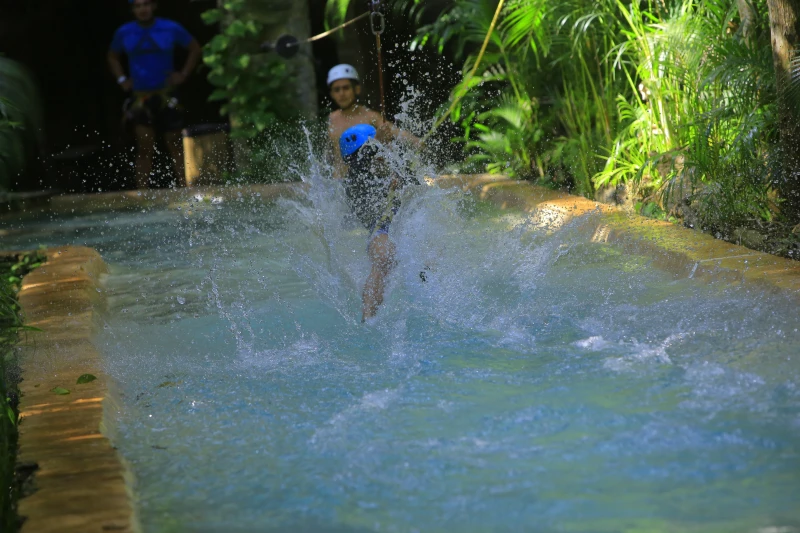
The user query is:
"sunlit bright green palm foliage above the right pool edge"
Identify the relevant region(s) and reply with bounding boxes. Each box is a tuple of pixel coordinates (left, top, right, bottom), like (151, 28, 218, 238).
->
(354, 0, 780, 228)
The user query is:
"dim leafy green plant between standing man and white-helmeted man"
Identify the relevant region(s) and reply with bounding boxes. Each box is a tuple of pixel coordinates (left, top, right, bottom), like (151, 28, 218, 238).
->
(203, 0, 295, 139)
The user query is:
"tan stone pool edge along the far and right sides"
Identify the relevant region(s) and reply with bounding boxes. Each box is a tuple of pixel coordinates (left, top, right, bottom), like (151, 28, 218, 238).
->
(10, 174, 800, 297)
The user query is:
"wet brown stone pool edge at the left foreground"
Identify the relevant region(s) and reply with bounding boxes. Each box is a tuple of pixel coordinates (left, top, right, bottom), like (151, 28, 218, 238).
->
(17, 246, 140, 533)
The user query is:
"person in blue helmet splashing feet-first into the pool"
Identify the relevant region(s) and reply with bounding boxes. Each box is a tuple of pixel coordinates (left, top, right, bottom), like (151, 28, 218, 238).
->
(339, 124, 424, 322)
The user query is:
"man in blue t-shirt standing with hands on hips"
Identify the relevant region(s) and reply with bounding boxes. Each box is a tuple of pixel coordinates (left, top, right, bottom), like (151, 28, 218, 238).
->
(108, 0, 201, 189)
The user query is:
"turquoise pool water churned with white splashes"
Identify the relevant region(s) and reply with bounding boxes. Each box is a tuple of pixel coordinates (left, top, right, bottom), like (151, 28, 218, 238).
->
(4, 187, 800, 533)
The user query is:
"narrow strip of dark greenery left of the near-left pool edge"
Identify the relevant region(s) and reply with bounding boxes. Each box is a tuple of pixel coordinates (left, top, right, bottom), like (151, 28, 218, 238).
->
(0, 251, 45, 531)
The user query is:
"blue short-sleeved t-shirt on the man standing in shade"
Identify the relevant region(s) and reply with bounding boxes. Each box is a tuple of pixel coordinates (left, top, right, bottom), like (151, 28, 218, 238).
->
(111, 18, 192, 91)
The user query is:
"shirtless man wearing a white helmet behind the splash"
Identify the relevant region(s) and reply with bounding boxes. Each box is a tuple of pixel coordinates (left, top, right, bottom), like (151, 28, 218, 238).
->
(328, 64, 422, 177)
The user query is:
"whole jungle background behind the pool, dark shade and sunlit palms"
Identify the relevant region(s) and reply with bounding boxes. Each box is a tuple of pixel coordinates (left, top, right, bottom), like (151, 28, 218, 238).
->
(0, 0, 800, 257)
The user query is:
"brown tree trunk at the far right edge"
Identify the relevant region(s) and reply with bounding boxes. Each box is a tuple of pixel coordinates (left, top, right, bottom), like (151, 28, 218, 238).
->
(767, 0, 800, 223)
